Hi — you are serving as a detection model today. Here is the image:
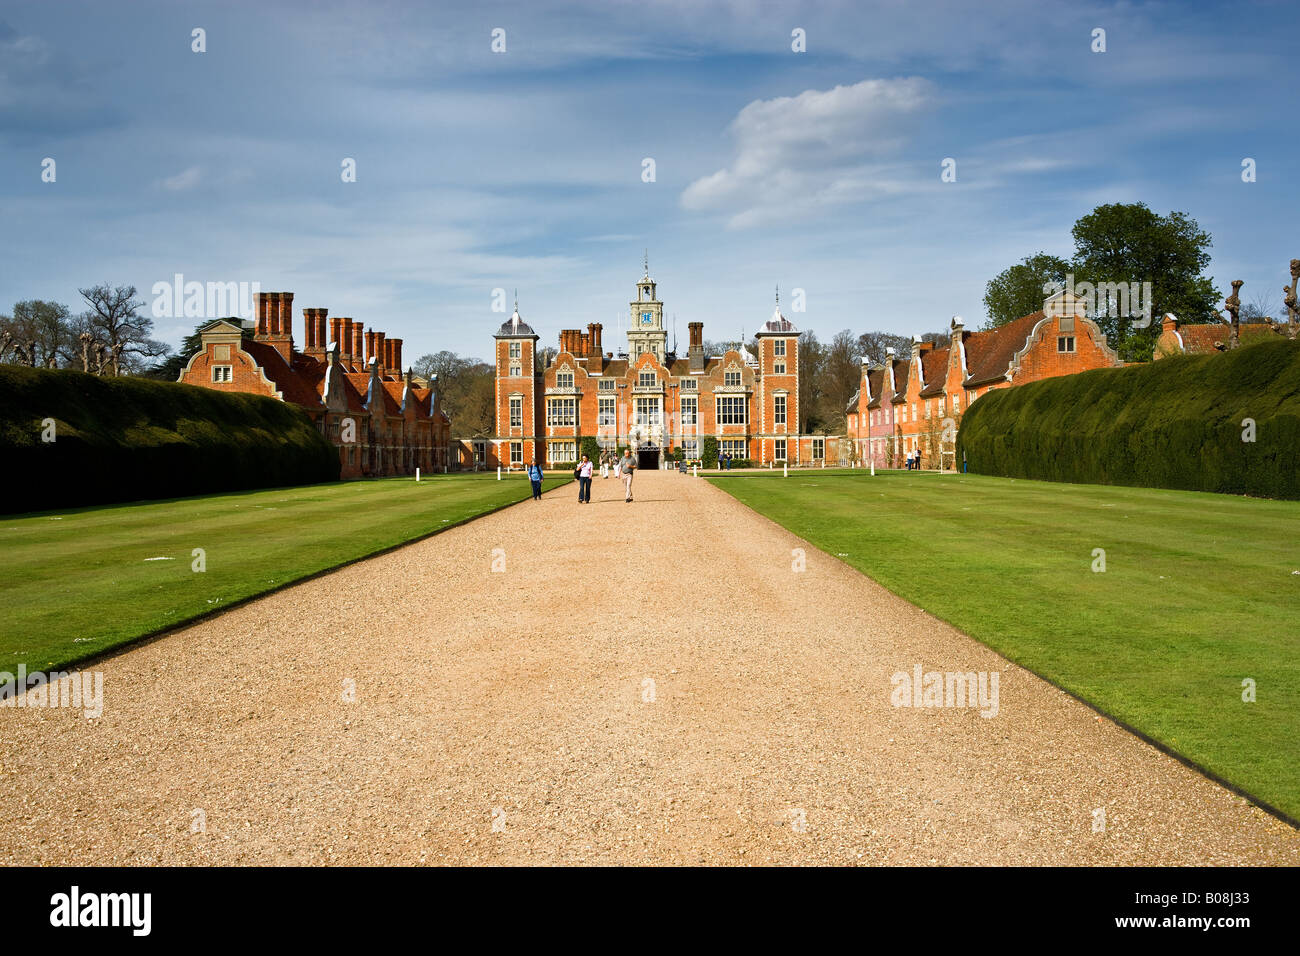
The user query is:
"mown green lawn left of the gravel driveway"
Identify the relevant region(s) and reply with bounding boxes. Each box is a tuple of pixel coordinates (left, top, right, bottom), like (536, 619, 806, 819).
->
(0, 473, 572, 674)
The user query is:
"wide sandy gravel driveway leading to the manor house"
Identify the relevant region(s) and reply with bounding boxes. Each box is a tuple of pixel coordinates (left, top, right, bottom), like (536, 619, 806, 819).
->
(0, 472, 1300, 865)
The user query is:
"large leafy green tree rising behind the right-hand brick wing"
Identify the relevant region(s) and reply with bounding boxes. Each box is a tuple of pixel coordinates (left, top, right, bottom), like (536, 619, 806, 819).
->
(1073, 203, 1222, 362)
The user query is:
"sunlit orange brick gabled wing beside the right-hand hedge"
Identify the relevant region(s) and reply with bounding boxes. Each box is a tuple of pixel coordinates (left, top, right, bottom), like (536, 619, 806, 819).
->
(846, 291, 1122, 470)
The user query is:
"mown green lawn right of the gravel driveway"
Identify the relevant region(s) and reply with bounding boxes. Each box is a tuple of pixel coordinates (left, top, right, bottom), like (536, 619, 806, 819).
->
(709, 470, 1300, 818)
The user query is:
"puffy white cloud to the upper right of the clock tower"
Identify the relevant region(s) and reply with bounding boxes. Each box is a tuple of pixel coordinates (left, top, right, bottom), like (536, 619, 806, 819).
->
(681, 77, 935, 229)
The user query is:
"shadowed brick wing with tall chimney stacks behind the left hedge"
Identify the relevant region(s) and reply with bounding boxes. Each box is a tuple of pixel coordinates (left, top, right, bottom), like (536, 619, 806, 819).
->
(179, 293, 451, 477)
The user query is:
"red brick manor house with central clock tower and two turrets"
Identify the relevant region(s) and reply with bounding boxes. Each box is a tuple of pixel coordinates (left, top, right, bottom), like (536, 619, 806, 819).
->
(477, 269, 827, 467)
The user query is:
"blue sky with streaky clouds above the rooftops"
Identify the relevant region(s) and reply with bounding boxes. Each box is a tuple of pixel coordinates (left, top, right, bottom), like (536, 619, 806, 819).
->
(0, 0, 1300, 362)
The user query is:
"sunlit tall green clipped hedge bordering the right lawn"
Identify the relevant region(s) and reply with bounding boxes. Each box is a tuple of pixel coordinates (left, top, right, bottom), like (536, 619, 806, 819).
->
(957, 338, 1300, 498)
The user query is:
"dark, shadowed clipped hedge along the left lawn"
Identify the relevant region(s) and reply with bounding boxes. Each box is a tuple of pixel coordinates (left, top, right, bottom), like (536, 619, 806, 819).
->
(0, 365, 339, 514)
